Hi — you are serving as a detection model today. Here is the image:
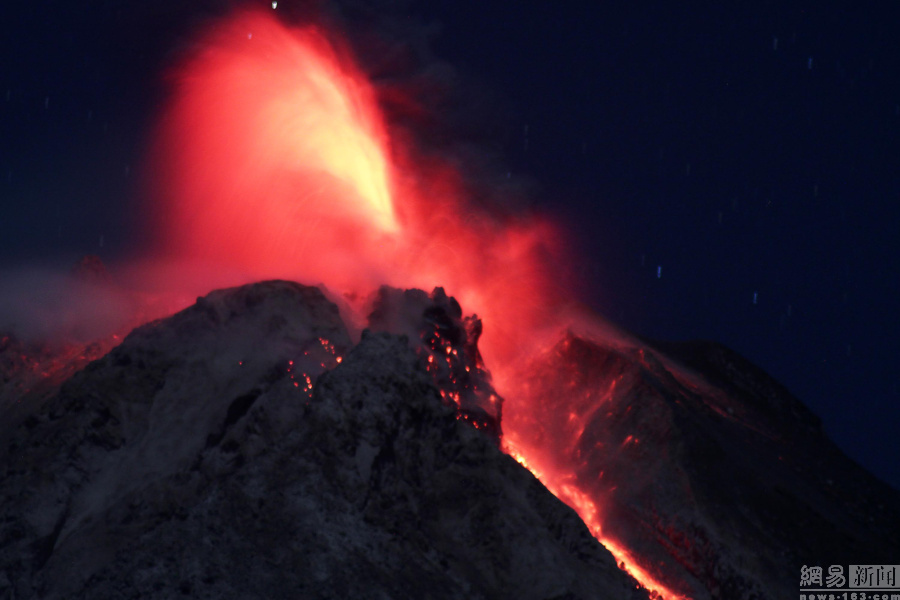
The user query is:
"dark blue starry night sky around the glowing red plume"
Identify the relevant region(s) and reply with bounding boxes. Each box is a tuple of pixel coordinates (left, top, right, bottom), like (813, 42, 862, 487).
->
(0, 0, 900, 487)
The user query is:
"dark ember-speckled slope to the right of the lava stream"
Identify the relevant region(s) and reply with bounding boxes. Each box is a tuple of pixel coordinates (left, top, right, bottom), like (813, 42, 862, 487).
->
(506, 335, 900, 600)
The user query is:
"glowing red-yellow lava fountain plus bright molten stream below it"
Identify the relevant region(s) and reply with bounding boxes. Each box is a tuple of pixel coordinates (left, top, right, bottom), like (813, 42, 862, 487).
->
(151, 11, 684, 597)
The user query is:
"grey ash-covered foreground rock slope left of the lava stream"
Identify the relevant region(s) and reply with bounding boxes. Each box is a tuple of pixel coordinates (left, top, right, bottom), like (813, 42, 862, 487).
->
(0, 282, 646, 600)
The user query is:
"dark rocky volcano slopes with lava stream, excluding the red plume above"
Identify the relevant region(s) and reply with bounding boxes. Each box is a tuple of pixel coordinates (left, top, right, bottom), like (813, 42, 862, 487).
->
(0, 281, 900, 599)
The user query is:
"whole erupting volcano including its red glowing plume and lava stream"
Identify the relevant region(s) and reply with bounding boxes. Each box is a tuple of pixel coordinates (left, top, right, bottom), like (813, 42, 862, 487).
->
(0, 3, 900, 600)
